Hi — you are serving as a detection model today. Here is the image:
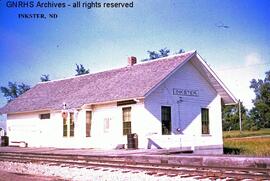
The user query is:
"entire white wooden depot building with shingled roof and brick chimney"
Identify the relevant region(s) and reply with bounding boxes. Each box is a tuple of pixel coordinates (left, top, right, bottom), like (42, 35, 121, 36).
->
(0, 51, 236, 153)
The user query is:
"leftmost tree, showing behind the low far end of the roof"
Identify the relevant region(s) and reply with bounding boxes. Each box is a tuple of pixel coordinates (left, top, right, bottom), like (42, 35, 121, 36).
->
(0, 82, 30, 102)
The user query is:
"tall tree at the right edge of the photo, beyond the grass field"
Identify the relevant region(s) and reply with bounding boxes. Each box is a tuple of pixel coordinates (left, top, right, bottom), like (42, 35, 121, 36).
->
(250, 70, 270, 128)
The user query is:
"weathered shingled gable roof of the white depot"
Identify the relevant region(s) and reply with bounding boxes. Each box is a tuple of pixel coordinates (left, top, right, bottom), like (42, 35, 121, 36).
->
(0, 51, 235, 113)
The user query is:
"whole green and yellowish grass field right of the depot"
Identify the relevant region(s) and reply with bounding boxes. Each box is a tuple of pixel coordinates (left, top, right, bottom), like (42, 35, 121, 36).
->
(223, 129, 270, 156)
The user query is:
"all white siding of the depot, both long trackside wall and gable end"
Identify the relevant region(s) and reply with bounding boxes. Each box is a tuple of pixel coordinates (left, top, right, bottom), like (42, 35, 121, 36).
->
(7, 61, 223, 151)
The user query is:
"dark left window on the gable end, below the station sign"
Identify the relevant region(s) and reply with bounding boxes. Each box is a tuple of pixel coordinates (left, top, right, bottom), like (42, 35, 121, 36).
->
(161, 106, 171, 135)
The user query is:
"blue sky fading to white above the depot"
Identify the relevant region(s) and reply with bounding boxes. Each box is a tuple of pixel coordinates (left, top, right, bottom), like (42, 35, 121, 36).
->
(0, 0, 270, 121)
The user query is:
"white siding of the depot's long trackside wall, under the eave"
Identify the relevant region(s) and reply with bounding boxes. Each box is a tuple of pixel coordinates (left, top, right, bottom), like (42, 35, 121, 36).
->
(7, 103, 148, 148)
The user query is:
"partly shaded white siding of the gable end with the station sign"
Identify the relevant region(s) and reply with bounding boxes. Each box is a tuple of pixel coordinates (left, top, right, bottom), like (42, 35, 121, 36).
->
(145, 61, 223, 147)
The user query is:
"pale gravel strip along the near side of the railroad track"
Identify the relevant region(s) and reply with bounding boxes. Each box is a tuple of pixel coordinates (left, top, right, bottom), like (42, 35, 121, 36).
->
(0, 161, 216, 181)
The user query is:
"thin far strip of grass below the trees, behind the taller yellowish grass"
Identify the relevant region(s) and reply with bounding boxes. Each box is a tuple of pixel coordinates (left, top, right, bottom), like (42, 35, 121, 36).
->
(223, 129, 270, 138)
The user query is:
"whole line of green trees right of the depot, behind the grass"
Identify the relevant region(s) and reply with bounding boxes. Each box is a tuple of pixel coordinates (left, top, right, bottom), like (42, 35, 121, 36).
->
(222, 70, 270, 131)
